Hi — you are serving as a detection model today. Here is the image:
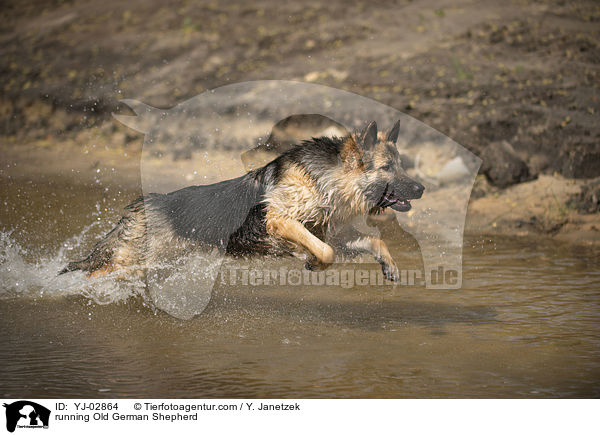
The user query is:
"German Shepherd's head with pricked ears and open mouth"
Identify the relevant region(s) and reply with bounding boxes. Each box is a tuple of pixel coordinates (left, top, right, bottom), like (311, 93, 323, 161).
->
(355, 121, 425, 212)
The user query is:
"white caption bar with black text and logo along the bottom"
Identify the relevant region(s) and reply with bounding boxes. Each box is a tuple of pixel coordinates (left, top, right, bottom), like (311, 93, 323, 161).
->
(1, 399, 598, 435)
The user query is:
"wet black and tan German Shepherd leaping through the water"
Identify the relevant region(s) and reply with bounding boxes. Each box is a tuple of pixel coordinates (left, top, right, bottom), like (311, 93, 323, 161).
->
(60, 121, 425, 280)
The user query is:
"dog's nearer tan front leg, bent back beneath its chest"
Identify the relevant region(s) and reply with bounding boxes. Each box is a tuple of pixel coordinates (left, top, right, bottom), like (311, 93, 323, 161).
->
(267, 218, 335, 270)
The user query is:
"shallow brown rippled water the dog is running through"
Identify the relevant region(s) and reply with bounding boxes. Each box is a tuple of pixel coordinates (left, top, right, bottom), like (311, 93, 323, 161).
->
(0, 177, 600, 398)
